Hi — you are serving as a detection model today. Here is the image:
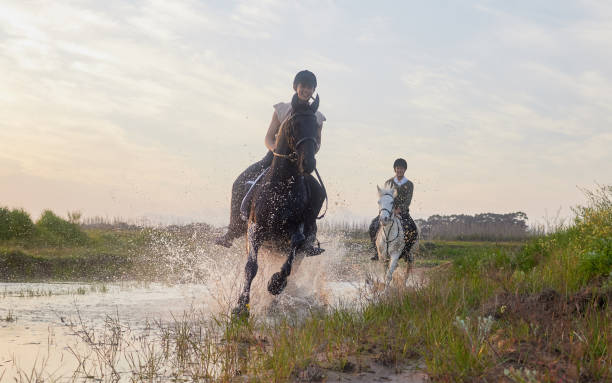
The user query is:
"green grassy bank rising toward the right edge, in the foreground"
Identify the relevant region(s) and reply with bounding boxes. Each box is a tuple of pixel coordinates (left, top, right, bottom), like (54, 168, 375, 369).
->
(148, 189, 612, 382)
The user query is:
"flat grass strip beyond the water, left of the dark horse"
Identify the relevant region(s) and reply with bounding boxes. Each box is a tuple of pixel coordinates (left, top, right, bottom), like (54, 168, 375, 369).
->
(0, 219, 220, 282)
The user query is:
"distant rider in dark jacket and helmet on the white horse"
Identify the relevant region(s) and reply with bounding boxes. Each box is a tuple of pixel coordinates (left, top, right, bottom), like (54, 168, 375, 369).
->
(369, 158, 418, 261)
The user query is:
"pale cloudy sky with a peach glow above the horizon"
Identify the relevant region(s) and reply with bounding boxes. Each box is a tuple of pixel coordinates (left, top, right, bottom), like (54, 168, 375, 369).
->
(0, 0, 612, 226)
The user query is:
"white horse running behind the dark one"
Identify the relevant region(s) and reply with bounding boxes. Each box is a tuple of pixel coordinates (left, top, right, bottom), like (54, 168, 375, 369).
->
(376, 186, 406, 285)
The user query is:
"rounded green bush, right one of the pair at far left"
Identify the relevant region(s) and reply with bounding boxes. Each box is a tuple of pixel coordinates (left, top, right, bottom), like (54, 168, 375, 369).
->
(36, 210, 89, 246)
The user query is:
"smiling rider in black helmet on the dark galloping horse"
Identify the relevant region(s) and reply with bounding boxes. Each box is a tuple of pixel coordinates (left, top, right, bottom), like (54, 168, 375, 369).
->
(215, 70, 326, 247)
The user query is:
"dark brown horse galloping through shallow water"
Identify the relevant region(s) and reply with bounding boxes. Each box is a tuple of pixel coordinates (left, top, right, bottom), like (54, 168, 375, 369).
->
(233, 96, 325, 315)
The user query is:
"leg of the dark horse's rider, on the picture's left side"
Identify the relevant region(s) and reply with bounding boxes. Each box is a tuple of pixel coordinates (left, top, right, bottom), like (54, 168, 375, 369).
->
(215, 152, 273, 247)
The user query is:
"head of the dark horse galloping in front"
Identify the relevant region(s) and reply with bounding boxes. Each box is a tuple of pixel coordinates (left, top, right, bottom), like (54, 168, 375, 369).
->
(283, 94, 319, 173)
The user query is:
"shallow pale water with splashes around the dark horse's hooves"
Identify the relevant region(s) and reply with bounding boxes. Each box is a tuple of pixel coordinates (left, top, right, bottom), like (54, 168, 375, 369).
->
(0, 236, 420, 382)
